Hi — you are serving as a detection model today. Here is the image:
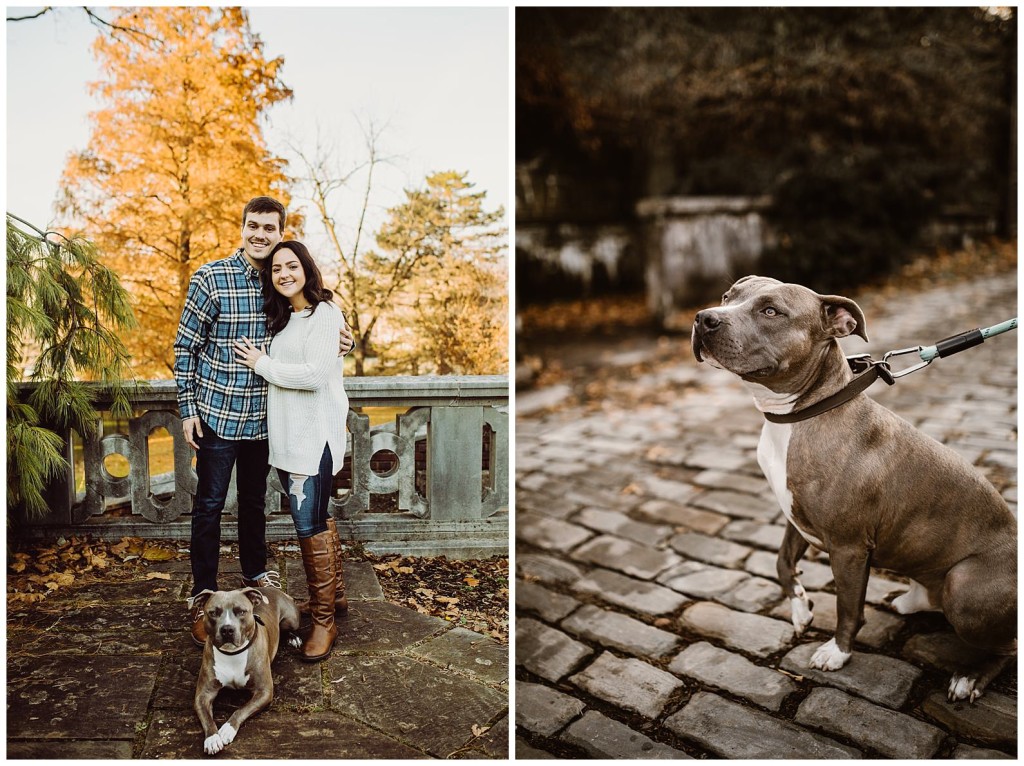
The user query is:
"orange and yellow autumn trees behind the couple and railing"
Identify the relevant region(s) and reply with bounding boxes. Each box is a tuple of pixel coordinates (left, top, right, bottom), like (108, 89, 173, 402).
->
(14, 6, 508, 379)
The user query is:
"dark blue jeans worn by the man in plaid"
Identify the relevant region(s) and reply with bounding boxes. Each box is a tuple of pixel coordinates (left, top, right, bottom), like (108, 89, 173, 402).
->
(191, 422, 270, 596)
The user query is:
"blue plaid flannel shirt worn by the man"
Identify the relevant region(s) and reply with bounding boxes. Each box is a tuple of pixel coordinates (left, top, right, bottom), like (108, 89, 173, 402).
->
(174, 249, 269, 439)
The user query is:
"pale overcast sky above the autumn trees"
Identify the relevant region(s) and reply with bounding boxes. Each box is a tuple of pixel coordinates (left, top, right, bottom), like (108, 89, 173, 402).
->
(6, 6, 511, 250)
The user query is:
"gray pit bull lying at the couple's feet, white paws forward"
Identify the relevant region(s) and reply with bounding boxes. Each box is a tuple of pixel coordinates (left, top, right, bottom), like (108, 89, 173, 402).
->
(189, 588, 302, 756)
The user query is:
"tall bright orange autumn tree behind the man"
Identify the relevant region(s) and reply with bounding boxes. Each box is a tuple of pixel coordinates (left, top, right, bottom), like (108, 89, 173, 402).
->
(58, 7, 301, 378)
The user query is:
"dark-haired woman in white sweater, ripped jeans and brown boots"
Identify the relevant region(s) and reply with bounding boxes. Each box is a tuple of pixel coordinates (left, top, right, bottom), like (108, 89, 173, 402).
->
(234, 241, 348, 661)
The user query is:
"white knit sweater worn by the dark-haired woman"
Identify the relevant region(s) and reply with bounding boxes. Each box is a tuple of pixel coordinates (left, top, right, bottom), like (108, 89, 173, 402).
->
(256, 301, 348, 476)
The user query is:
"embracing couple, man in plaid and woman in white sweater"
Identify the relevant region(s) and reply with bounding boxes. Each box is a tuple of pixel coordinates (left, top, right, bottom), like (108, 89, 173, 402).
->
(174, 197, 352, 661)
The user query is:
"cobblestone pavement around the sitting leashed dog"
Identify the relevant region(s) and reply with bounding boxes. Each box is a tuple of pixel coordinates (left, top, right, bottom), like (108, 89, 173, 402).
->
(514, 274, 1018, 759)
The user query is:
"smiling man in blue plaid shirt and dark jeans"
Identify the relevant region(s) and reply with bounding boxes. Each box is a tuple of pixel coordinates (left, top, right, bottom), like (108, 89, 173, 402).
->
(174, 197, 352, 646)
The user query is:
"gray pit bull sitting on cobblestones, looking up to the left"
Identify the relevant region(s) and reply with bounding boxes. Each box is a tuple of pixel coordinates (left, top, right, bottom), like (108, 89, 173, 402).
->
(691, 276, 1017, 703)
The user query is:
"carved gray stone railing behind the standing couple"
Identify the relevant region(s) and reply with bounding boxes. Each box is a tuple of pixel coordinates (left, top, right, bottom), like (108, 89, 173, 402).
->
(16, 376, 509, 557)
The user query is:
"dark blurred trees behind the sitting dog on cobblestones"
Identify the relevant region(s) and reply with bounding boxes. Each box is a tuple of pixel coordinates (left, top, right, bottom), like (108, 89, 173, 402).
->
(516, 7, 1017, 302)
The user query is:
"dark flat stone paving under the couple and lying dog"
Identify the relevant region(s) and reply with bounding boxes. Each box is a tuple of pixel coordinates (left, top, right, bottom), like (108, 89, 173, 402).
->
(6, 555, 509, 761)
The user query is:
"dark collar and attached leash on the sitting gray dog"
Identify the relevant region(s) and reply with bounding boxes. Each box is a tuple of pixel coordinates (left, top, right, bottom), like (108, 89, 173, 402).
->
(764, 316, 1017, 423)
